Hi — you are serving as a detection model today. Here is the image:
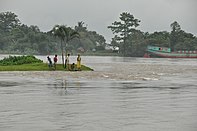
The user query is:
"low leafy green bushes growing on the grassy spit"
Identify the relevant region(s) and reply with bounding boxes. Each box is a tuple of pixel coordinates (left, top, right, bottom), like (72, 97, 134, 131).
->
(0, 56, 43, 66)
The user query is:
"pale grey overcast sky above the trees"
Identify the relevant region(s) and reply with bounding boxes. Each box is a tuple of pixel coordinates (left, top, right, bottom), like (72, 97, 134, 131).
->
(0, 0, 197, 41)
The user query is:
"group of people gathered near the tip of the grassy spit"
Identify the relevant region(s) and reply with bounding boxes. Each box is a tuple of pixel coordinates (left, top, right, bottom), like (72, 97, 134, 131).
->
(47, 54, 81, 71)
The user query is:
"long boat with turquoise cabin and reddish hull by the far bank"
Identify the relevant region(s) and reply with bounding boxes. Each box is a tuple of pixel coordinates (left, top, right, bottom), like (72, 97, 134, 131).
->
(144, 46, 197, 58)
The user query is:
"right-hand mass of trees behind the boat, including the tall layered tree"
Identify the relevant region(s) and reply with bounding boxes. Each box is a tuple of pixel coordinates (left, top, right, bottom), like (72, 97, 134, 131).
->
(108, 12, 197, 56)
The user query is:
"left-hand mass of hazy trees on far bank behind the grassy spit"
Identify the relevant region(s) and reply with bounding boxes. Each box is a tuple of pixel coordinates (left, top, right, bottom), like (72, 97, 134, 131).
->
(0, 12, 105, 55)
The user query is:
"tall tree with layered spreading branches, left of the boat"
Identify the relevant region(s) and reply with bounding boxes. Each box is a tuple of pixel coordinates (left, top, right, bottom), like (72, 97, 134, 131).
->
(108, 12, 142, 56)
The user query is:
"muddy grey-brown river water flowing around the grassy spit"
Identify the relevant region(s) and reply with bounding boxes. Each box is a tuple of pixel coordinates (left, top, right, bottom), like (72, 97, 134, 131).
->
(0, 55, 197, 131)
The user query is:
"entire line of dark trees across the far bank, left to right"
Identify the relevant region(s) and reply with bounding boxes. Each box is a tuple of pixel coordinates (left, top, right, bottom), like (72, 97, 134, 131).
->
(0, 12, 197, 57)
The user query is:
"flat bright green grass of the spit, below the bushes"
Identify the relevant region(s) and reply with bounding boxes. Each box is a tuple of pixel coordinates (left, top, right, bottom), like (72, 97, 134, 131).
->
(0, 63, 93, 71)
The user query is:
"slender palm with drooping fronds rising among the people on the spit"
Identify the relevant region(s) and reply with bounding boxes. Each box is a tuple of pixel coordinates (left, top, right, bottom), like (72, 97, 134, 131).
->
(50, 25, 79, 67)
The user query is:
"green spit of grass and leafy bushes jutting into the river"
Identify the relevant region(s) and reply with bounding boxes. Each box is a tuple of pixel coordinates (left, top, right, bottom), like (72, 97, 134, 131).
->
(0, 56, 93, 71)
